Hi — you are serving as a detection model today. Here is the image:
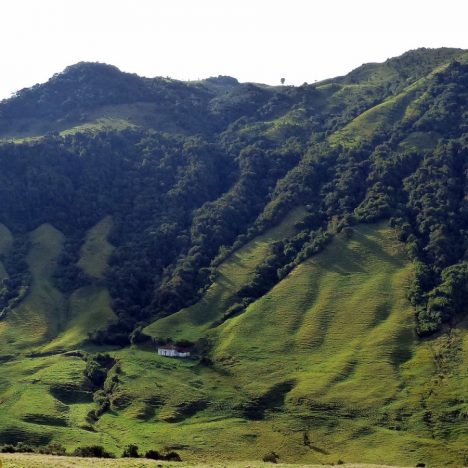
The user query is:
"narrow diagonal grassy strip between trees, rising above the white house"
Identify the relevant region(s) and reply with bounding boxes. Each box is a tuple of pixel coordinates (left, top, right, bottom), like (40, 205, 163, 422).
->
(145, 208, 305, 340)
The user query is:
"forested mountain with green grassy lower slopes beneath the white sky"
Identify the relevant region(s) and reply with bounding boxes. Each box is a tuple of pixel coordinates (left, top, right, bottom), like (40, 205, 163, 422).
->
(0, 48, 468, 466)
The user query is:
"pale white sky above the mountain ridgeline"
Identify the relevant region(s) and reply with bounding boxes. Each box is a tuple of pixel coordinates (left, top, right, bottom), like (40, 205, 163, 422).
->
(0, 0, 468, 99)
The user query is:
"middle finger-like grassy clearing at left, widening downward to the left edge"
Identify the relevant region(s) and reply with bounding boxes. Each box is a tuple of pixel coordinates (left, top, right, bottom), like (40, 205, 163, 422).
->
(0, 224, 66, 352)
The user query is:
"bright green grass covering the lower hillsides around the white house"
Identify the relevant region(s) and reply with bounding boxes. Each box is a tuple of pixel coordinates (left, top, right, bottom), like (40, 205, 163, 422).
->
(0, 218, 468, 466)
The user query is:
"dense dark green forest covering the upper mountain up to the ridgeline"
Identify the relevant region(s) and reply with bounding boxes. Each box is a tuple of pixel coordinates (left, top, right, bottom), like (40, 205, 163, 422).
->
(0, 49, 468, 344)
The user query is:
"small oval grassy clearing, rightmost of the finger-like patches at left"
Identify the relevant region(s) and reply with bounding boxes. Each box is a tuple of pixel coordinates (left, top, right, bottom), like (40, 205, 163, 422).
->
(78, 216, 113, 278)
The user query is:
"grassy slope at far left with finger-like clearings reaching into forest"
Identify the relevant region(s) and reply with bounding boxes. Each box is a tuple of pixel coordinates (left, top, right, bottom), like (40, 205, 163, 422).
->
(0, 217, 115, 354)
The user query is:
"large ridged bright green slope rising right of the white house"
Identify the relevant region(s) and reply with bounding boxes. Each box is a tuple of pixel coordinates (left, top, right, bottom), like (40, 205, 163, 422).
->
(215, 226, 414, 402)
